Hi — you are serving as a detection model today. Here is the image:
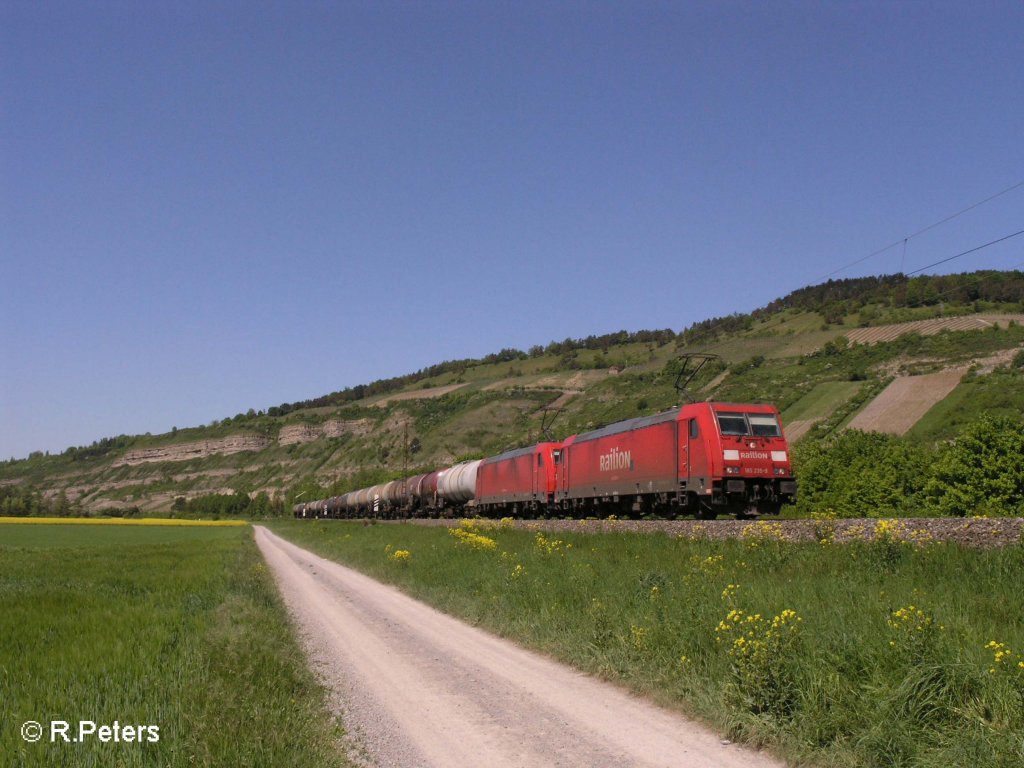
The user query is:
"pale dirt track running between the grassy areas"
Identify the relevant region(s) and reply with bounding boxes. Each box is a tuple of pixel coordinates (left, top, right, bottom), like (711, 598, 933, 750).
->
(256, 526, 782, 768)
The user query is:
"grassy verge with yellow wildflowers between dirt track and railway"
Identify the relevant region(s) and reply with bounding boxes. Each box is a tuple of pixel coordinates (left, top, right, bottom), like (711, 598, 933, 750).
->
(270, 521, 1024, 767)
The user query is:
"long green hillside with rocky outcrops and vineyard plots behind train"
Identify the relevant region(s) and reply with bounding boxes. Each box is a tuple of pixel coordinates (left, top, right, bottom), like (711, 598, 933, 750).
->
(6, 272, 1024, 513)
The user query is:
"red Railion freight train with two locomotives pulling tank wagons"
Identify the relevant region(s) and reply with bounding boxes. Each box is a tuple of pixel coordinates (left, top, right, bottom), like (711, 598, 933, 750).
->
(293, 402, 797, 519)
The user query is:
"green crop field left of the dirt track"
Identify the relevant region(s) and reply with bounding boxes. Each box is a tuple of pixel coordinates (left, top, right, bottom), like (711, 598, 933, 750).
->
(0, 524, 346, 767)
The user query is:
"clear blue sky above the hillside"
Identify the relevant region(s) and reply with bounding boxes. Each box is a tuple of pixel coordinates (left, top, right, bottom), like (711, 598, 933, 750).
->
(0, 0, 1024, 458)
